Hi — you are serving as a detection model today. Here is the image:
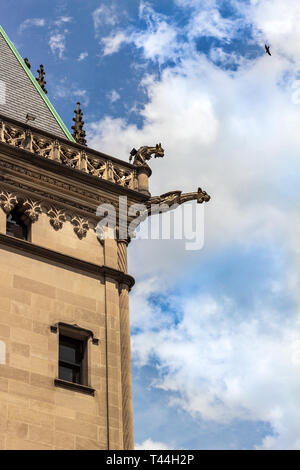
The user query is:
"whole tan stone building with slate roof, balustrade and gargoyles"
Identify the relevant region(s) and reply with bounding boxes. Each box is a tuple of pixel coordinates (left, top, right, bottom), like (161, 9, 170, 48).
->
(0, 26, 209, 450)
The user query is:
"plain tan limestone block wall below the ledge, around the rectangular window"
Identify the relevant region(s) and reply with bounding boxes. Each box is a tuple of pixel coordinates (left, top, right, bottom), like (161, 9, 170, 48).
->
(0, 246, 123, 449)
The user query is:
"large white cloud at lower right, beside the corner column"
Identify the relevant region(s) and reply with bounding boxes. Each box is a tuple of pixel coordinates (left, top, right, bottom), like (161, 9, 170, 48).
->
(133, 288, 300, 449)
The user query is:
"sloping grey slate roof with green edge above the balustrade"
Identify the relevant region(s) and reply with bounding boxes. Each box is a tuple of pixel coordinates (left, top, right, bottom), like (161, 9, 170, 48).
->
(0, 25, 74, 142)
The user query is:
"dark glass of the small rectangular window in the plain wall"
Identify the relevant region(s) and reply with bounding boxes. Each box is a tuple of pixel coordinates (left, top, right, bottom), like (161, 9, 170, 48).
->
(59, 335, 84, 384)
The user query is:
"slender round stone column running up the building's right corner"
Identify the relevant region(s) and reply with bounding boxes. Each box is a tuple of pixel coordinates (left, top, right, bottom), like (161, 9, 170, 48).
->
(118, 240, 134, 450)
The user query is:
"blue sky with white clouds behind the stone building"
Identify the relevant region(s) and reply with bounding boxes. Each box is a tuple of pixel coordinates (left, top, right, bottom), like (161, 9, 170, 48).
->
(0, 0, 300, 449)
